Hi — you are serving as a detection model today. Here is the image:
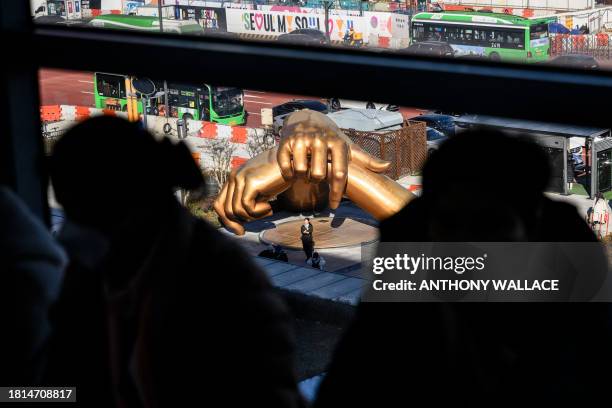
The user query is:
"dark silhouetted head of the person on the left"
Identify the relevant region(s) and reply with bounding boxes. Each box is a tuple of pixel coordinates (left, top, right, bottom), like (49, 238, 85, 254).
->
(50, 116, 203, 234)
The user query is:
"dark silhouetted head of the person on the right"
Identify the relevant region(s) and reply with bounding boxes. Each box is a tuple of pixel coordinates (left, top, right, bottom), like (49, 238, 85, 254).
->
(422, 129, 550, 241)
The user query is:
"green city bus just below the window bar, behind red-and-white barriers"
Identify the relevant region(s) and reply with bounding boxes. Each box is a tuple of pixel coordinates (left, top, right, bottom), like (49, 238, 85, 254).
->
(94, 72, 246, 125)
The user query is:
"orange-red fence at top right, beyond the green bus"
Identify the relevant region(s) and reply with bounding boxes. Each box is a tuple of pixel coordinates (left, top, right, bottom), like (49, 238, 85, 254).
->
(550, 33, 612, 59)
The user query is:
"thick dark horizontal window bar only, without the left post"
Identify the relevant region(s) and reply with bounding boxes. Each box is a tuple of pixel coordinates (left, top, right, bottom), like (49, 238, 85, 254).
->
(33, 27, 612, 126)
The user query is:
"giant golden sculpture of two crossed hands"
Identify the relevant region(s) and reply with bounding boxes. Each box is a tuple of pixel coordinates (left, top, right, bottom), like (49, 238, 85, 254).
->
(214, 109, 414, 235)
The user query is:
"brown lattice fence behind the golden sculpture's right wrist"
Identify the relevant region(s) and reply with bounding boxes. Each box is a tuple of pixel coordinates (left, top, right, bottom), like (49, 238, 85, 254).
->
(343, 121, 427, 180)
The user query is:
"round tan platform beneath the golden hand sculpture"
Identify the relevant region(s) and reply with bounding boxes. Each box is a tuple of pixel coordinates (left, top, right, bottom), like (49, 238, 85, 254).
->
(259, 217, 378, 249)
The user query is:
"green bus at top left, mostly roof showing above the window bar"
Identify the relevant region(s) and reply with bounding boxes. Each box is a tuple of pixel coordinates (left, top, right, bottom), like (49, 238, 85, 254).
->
(89, 14, 204, 35)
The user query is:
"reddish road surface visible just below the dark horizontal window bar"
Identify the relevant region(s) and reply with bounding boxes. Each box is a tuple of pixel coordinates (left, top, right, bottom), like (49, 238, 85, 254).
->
(39, 69, 424, 127)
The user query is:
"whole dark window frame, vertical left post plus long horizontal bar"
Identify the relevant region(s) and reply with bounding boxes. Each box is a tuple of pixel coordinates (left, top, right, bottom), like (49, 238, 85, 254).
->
(0, 1, 612, 220)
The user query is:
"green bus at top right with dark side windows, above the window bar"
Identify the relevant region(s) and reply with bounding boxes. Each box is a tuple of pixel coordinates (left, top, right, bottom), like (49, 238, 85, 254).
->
(411, 11, 551, 62)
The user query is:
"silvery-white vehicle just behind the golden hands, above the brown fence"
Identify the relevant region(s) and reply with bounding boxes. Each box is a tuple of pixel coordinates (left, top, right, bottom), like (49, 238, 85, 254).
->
(327, 109, 404, 132)
